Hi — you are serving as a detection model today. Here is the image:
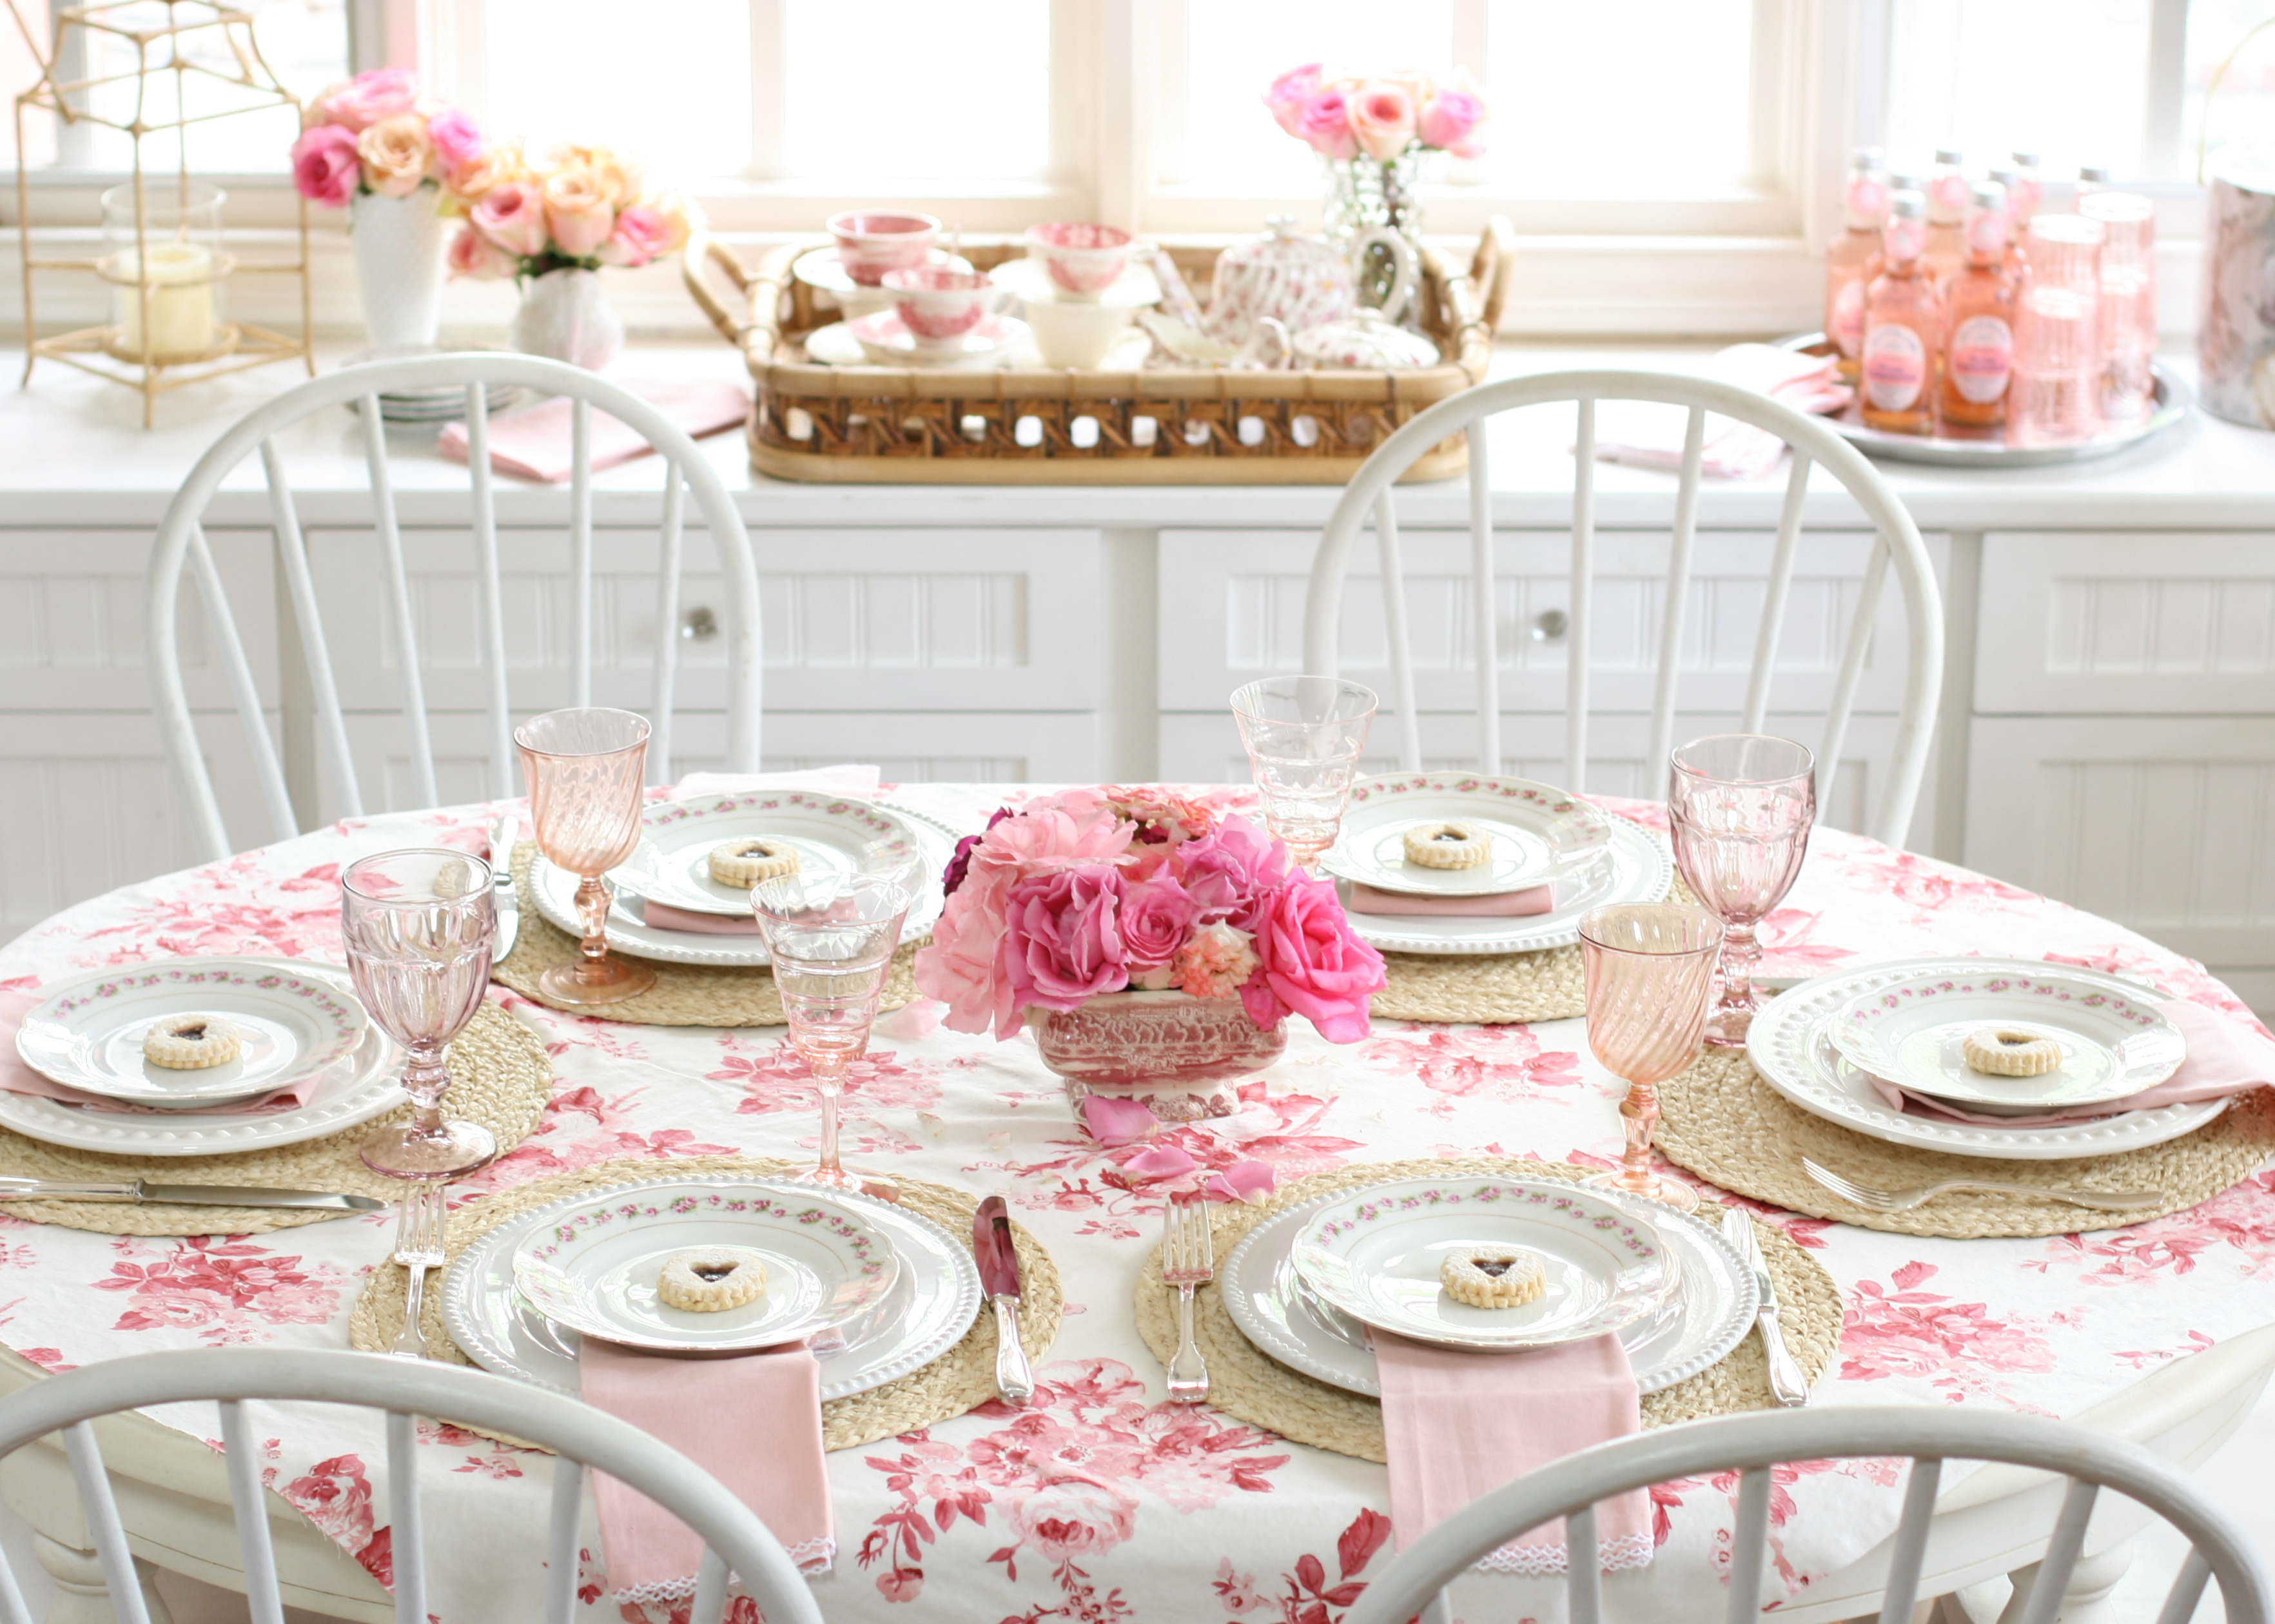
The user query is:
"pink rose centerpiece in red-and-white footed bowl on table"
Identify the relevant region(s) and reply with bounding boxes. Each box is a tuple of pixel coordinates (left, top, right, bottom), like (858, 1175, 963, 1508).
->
(917, 787, 1383, 1121)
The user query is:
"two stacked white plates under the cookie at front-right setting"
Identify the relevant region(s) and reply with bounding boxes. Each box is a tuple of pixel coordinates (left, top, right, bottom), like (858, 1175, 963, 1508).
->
(1217, 1176, 1759, 1396)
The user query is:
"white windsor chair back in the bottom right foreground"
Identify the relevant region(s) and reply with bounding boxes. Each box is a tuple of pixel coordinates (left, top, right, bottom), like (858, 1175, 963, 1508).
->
(1345, 1404, 2275, 1624)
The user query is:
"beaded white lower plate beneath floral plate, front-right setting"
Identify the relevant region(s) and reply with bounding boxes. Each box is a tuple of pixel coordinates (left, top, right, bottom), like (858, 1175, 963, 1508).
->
(1217, 1192, 1761, 1399)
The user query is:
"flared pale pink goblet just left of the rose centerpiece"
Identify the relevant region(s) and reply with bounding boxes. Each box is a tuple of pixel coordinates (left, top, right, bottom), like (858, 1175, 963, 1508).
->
(751, 869, 915, 1201)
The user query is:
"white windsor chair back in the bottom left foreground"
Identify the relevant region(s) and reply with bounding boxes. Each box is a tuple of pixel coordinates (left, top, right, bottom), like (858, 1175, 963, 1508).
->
(0, 1349, 821, 1624)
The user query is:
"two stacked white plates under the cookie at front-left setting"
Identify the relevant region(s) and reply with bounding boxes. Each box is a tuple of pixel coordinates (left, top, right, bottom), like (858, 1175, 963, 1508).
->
(442, 1176, 981, 1399)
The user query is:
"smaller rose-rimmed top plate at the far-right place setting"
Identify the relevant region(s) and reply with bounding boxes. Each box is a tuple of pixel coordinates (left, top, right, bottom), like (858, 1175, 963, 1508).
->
(1827, 964, 2186, 1115)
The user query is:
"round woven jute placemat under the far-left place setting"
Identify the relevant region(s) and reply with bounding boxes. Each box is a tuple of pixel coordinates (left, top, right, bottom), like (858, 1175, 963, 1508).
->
(0, 1003, 553, 1235)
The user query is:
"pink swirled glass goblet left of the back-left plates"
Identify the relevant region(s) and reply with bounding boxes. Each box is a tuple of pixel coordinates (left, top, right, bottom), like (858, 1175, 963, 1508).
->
(514, 710, 655, 1003)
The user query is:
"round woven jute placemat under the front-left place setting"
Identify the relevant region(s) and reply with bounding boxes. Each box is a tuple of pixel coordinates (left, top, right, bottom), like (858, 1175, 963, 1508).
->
(348, 1155, 1065, 1449)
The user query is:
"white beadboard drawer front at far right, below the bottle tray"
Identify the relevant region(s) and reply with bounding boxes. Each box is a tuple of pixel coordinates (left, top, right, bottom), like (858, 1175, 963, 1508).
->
(1975, 533, 2275, 714)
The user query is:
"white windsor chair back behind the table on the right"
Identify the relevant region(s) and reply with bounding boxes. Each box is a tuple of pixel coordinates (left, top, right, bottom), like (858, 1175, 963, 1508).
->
(1303, 371, 1943, 846)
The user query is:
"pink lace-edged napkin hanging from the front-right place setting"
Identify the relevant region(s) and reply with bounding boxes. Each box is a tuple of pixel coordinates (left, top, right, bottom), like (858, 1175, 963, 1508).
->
(1372, 1331, 1652, 1576)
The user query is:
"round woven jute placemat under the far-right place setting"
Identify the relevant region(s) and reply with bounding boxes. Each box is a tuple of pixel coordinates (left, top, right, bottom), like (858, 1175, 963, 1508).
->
(1654, 1048, 2275, 1240)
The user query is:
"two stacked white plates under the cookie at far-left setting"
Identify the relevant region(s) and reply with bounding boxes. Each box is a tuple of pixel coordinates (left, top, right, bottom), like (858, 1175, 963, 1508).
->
(0, 955, 403, 1155)
